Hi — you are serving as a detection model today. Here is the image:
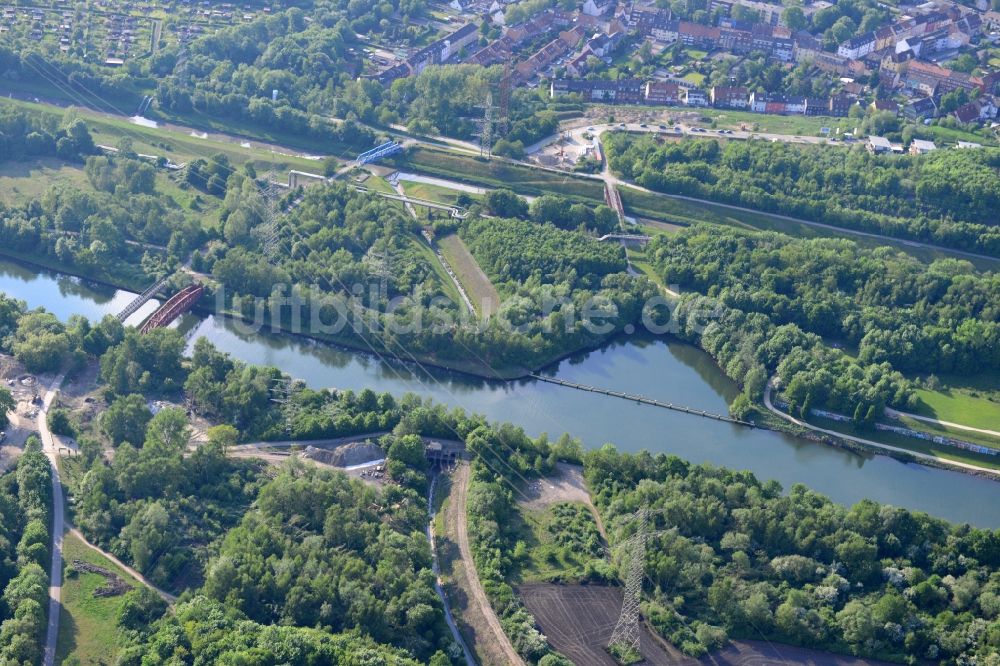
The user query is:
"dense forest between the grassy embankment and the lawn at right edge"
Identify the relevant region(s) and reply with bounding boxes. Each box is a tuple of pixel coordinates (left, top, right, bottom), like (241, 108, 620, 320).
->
(649, 226, 1000, 374)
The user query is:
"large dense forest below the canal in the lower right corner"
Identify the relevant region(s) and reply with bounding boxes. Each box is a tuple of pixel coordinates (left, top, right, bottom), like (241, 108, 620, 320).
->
(585, 446, 1000, 664)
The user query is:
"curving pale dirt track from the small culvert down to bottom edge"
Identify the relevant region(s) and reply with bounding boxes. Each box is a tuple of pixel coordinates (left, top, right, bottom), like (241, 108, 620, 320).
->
(447, 463, 524, 666)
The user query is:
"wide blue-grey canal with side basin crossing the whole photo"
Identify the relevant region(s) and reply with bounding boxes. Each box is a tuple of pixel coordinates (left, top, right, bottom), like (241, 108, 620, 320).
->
(7, 260, 1000, 527)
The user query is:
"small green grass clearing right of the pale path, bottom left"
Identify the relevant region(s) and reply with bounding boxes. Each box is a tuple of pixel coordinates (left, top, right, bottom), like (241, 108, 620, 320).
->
(56, 534, 140, 666)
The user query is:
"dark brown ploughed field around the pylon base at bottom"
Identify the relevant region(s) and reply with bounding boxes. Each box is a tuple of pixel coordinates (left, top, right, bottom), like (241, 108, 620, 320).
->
(518, 583, 888, 666)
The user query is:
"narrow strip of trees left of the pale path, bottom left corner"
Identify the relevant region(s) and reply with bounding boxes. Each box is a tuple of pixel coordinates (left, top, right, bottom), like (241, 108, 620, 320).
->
(0, 436, 52, 665)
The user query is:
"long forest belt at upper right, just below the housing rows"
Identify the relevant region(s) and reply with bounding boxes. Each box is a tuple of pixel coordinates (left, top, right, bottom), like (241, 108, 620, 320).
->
(604, 133, 1000, 255)
